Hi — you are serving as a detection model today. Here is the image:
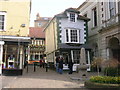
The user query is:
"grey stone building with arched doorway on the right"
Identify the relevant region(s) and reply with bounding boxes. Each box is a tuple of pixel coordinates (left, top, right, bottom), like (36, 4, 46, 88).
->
(77, 0, 120, 61)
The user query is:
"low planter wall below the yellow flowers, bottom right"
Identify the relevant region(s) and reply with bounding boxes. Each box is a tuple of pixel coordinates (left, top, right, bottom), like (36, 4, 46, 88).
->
(84, 81, 120, 89)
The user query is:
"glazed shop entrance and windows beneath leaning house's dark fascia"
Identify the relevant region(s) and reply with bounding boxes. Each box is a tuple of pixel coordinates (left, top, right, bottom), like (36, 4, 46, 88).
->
(61, 50, 91, 71)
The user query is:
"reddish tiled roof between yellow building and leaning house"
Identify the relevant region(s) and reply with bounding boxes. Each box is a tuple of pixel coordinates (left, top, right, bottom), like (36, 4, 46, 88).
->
(29, 27, 45, 38)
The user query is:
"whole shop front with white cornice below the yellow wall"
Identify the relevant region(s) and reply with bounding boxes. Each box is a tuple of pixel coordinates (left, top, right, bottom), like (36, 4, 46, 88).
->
(2, 37, 30, 75)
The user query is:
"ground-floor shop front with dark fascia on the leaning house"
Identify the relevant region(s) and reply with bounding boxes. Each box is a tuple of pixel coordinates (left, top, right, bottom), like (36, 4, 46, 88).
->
(57, 44, 91, 71)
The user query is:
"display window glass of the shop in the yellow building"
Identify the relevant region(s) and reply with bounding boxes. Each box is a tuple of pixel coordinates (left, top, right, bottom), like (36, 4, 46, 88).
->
(3, 45, 23, 69)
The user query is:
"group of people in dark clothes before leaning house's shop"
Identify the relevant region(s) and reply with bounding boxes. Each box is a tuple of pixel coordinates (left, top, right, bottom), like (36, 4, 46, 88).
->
(56, 55, 73, 74)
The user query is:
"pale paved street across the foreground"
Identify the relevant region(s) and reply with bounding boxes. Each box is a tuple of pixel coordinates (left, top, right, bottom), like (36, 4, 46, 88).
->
(2, 66, 102, 88)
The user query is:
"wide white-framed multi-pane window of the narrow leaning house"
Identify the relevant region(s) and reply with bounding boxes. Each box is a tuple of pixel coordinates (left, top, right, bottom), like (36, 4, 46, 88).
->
(66, 29, 80, 43)
